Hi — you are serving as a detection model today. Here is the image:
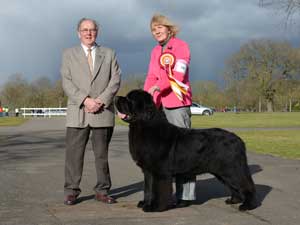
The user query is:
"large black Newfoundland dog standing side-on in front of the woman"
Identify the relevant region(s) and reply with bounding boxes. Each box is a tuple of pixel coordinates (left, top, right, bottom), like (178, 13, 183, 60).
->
(115, 90, 258, 212)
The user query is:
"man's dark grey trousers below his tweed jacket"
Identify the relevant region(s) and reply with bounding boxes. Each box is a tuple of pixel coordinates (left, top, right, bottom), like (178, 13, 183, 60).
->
(64, 126, 113, 195)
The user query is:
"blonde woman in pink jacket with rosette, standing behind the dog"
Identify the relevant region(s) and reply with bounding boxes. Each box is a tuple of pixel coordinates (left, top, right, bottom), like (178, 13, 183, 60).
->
(144, 14, 196, 207)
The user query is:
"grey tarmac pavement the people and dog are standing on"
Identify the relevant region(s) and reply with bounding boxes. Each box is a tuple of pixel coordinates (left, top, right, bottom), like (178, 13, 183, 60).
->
(0, 118, 300, 225)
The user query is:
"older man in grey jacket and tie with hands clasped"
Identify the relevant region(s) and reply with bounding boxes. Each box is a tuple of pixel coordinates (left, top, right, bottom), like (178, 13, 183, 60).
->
(61, 18, 121, 205)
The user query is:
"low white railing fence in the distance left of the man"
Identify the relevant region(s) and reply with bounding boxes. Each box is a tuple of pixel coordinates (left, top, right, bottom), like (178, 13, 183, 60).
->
(20, 108, 67, 118)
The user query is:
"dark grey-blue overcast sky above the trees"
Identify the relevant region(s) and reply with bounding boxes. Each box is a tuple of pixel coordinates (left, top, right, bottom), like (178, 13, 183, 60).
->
(0, 0, 300, 85)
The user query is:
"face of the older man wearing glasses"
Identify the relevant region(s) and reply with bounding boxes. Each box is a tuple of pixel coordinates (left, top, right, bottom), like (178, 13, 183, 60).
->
(78, 20, 98, 47)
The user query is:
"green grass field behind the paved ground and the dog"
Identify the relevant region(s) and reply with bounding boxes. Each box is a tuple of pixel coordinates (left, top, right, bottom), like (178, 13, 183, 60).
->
(0, 112, 300, 159)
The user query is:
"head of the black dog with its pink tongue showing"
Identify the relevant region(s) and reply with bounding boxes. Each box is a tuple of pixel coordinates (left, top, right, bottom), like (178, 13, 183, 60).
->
(115, 89, 157, 123)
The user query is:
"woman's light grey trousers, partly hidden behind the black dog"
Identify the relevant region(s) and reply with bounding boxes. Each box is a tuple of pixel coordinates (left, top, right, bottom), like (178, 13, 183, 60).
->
(163, 107, 196, 200)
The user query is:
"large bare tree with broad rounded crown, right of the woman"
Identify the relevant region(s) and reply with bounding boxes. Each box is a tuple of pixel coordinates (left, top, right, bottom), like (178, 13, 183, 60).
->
(224, 40, 300, 112)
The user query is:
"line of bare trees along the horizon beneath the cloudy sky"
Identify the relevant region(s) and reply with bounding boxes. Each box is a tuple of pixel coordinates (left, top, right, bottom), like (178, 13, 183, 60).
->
(0, 40, 300, 112)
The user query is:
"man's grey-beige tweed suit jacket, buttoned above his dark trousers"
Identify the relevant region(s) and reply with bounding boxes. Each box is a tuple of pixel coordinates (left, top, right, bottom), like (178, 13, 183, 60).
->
(60, 45, 121, 127)
